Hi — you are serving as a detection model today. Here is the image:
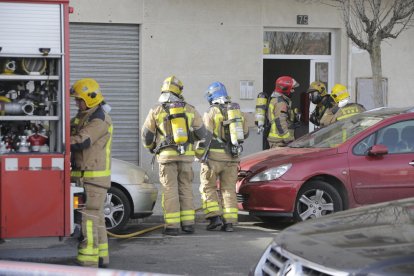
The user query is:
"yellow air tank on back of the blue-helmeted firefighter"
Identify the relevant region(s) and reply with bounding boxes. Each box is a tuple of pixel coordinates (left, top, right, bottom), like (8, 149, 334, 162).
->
(227, 103, 244, 155)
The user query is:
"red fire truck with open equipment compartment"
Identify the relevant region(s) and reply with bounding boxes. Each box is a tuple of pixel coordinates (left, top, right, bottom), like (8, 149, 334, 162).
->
(0, 0, 77, 239)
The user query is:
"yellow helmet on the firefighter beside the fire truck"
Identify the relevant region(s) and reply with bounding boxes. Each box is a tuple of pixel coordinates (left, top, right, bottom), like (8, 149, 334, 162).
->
(70, 78, 104, 108)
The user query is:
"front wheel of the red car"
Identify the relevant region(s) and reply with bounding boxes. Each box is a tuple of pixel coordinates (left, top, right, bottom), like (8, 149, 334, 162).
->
(293, 181, 343, 221)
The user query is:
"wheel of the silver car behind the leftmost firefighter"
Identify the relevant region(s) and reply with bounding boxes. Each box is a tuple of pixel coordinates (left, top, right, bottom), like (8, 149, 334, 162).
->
(104, 187, 131, 233)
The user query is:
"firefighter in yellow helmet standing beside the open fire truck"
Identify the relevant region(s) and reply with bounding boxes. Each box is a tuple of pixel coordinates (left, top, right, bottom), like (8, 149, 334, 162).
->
(70, 78, 112, 267)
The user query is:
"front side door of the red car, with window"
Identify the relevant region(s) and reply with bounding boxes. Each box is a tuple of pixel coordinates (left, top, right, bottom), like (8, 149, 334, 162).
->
(349, 120, 414, 204)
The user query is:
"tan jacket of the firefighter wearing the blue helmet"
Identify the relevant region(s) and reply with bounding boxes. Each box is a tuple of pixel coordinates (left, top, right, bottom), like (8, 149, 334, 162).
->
(203, 104, 249, 162)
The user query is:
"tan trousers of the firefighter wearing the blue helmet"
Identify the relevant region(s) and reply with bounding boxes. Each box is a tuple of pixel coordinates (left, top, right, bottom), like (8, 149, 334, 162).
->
(200, 160, 238, 223)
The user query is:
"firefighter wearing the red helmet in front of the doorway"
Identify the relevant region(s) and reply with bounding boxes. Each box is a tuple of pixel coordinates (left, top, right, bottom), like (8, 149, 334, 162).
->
(267, 76, 299, 148)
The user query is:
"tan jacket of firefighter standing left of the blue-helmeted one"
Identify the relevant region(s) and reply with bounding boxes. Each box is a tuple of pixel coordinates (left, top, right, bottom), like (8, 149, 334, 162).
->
(141, 103, 206, 163)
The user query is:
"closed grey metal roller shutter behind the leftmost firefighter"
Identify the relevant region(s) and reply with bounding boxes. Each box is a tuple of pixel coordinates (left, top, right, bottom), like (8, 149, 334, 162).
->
(70, 23, 140, 164)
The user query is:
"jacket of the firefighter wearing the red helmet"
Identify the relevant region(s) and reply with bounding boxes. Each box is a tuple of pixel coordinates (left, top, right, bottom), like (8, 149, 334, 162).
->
(267, 92, 295, 145)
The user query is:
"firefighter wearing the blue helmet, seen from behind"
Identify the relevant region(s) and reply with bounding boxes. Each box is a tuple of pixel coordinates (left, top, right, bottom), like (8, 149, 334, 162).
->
(200, 82, 249, 232)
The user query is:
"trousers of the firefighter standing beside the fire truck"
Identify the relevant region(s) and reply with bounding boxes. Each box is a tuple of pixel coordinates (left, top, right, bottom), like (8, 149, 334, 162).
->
(77, 181, 109, 267)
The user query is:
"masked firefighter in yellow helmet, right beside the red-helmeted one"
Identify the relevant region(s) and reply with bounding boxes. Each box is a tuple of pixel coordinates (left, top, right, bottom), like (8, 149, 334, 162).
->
(307, 81, 334, 126)
